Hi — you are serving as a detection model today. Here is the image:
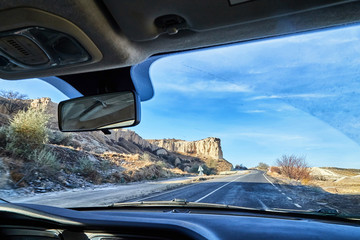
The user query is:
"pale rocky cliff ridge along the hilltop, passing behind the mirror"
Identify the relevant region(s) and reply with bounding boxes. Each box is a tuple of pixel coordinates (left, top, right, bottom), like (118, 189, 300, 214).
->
(0, 98, 232, 172)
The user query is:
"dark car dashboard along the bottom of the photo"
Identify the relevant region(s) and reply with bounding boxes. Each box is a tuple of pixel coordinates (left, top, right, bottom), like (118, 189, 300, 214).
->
(0, 204, 360, 240)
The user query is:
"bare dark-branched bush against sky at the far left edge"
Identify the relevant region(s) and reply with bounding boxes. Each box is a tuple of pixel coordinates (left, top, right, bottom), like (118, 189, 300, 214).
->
(0, 90, 28, 115)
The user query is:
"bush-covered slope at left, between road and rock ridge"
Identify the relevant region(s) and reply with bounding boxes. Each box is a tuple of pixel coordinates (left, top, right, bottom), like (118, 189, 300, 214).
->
(0, 91, 191, 192)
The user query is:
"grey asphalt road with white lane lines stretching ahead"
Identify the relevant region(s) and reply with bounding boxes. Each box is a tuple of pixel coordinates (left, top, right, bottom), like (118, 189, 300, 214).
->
(132, 170, 321, 210)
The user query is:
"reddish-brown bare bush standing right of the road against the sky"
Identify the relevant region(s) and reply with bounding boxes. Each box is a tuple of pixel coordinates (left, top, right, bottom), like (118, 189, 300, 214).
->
(276, 155, 310, 180)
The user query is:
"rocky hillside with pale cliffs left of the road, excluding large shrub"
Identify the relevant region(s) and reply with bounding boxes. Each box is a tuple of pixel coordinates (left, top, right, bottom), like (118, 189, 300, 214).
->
(0, 98, 232, 192)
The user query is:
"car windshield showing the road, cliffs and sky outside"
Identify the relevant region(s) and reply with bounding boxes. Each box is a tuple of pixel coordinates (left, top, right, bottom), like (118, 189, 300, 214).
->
(0, 25, 360, 217)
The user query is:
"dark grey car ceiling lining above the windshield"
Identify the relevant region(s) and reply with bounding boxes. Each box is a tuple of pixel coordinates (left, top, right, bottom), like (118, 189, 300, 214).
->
(0, 0, 360, 95)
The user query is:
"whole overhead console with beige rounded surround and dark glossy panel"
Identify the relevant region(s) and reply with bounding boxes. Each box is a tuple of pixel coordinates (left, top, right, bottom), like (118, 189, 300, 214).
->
(0, 8, 102, 74)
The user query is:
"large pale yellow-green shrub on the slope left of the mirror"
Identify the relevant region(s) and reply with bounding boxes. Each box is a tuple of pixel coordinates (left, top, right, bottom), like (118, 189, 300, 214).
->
(6, 107, 49, 158)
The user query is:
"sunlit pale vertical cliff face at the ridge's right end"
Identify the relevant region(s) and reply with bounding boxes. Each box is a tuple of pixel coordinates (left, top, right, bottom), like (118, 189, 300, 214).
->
(147, 137, 223, 159)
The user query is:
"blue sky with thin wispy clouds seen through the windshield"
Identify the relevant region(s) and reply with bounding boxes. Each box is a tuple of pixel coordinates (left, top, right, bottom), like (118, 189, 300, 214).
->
(0, 23, 360, 168)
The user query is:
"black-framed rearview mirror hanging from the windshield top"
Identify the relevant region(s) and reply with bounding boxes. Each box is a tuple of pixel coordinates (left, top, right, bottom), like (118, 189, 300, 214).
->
(58, 91, 140, 132)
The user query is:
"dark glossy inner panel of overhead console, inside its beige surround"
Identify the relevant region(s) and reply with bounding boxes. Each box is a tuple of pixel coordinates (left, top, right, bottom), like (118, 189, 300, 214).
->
(0, 27, 91, 72)
